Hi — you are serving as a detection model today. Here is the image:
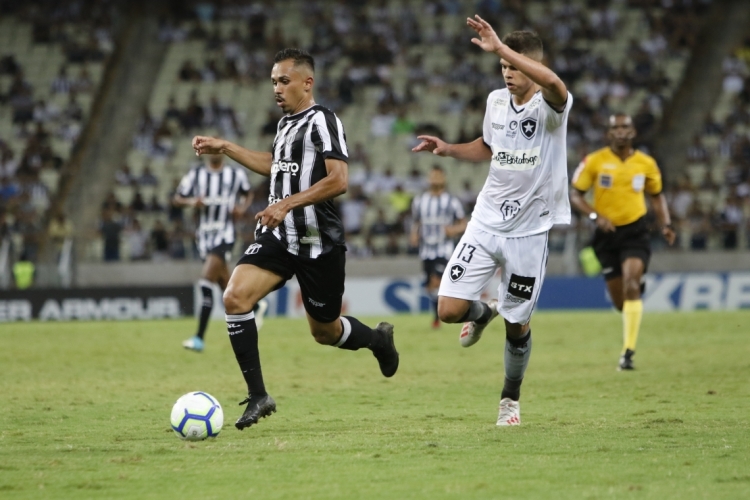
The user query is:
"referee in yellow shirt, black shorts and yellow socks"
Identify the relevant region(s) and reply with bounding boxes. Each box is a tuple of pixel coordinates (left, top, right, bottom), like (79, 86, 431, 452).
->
(570, 114, 675, 370)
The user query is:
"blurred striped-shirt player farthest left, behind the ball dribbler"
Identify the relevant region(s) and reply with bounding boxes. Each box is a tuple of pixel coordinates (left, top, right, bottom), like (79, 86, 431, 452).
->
(174, 155, 268, 352)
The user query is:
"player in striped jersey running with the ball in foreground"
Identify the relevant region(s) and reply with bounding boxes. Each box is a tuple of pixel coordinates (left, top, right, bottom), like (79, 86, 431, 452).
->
(193, 49, 399, 430)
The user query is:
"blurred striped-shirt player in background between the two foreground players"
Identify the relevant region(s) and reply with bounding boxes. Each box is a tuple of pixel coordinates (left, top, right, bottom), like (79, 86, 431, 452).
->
(410, 166, 466, 328)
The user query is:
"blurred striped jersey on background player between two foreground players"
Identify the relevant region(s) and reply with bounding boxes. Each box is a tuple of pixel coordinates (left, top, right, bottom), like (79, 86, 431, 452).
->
(412, 191, 466, 260)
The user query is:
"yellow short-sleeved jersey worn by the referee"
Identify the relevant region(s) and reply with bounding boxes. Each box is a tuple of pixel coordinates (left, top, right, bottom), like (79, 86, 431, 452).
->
(573, 147, 662, 226)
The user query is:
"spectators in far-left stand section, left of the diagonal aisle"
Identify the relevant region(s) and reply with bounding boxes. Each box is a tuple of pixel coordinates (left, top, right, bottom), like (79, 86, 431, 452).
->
(0, 0, 113, 282)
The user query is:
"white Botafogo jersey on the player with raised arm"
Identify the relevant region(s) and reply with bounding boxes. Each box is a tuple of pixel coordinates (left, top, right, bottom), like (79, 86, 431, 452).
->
(470, 89, 573, 237)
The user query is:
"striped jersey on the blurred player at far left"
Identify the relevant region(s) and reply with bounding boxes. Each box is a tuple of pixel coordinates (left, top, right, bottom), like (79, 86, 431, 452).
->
(177, 165, 250, 259)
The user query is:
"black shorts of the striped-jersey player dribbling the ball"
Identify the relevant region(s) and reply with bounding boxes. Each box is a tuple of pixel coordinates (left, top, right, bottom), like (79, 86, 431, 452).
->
(237, 231, 346, 323)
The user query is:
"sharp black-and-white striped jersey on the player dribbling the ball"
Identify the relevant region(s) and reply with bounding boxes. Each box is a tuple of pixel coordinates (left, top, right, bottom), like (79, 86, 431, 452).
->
(256, 104, 349, 259)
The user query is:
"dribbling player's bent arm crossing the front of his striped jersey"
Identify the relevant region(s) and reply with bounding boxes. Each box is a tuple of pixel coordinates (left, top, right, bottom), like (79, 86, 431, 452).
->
(255, 158, 349, 229)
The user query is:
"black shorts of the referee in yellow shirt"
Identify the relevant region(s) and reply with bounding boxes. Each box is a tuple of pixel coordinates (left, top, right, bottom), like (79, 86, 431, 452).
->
(591, 217, 651, 280)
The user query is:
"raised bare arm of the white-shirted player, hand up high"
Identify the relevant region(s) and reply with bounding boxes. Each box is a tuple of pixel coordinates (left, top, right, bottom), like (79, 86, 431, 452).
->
(466, 16, 568, 108)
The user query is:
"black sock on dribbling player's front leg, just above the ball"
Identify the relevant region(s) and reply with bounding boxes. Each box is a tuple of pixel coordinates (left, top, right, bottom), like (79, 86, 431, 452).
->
(226, 311, 267, 396)
